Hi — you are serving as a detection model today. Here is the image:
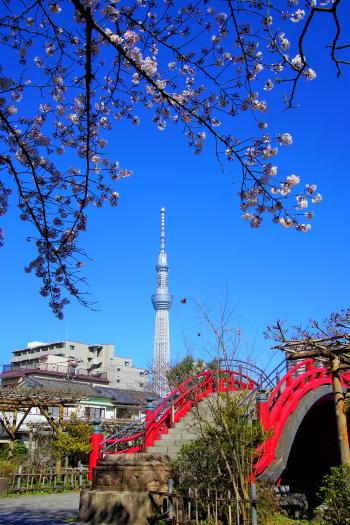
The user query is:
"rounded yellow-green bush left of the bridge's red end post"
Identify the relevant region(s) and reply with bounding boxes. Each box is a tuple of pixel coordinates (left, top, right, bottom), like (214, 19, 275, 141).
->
(53, 412, 93, 466)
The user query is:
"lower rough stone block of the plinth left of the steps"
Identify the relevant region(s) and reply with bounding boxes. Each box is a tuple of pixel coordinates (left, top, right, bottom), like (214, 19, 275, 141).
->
(79, 490, 155, 525)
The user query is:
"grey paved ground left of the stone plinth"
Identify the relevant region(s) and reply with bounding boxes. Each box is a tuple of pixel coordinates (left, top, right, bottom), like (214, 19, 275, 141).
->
(0, 493, 81, 525)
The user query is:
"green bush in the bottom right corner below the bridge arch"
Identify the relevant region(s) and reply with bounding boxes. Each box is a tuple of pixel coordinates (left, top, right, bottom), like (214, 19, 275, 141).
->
(319, 465, 350, 525)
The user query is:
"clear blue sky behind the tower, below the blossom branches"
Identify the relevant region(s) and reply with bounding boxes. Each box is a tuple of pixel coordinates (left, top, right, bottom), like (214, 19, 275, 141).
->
(0, 4, 350, 372)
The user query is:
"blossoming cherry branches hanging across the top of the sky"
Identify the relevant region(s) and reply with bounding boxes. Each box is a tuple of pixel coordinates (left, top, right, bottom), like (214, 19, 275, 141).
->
(0, 0, 348, 318)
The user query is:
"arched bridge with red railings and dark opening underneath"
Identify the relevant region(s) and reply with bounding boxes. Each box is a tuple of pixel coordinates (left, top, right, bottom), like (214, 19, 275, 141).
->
(90, 359, 350, 482)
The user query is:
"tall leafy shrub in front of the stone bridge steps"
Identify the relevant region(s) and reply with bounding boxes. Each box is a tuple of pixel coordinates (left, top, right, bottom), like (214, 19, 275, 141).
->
(174, 393, 266, 521)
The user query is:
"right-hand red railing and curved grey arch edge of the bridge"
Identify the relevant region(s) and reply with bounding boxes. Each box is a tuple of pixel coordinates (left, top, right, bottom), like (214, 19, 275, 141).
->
(255, 359, 350, 482)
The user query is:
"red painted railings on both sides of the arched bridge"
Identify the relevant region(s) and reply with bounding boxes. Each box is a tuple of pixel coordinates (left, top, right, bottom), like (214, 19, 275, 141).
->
(91, 359, 350, 482)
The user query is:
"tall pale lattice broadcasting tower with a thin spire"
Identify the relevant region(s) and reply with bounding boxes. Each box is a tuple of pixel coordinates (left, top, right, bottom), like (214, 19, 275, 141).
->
(152, 208, 173, 397)
